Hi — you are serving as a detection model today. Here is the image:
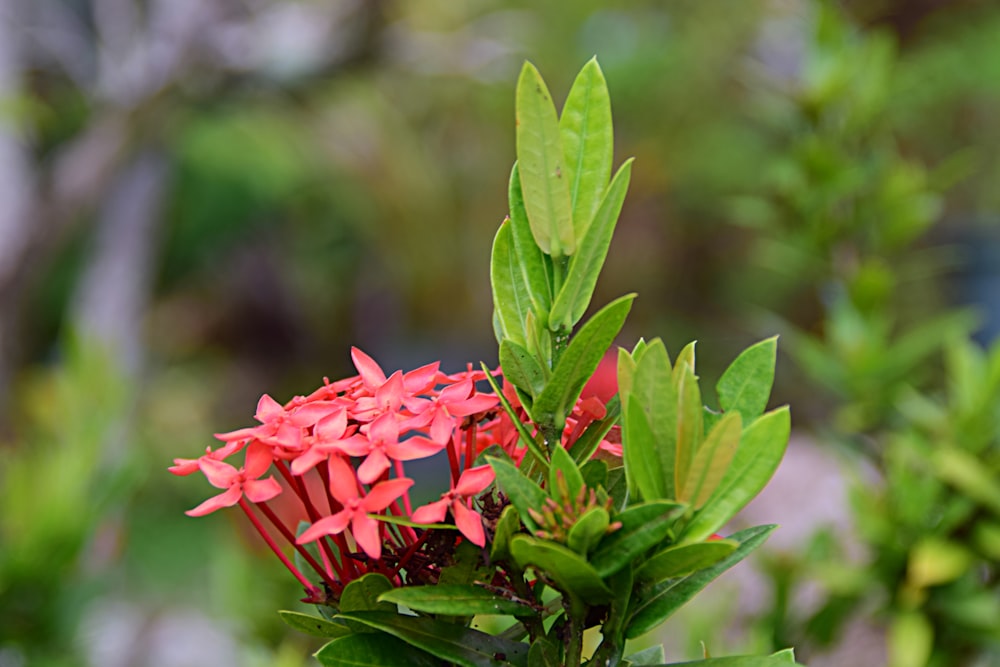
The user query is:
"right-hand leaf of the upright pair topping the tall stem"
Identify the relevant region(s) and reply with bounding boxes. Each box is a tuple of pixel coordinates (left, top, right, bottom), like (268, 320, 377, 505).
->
(559, 58, 614, 239)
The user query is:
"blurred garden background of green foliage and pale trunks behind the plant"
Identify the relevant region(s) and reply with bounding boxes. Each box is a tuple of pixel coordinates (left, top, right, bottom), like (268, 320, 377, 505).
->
(0, 0, 1000, 667)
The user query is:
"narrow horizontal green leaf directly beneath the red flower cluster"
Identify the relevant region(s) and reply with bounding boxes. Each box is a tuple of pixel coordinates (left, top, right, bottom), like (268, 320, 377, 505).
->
(379, 584, 537, 616)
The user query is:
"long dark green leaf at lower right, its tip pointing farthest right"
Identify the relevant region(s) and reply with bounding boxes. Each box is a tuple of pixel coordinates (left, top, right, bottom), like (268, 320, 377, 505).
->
(625, 526, 777, 639)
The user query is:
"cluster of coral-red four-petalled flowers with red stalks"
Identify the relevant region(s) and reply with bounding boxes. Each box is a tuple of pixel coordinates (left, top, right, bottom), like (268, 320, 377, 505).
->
(170, 348, 614, 602)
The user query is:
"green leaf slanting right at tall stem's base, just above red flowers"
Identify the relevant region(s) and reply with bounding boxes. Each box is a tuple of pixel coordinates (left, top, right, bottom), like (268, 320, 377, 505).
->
(532, 294, 635, 430)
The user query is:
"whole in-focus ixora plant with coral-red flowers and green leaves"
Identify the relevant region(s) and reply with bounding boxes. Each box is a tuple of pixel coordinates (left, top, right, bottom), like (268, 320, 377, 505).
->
(171, 60, 794, 667)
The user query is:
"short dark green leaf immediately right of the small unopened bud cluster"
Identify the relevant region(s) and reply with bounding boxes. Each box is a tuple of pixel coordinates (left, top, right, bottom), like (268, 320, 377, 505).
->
(590, 500, 685, 577)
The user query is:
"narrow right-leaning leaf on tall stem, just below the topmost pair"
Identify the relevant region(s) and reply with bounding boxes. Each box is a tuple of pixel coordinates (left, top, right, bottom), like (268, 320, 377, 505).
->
(549, 159, 632, 331)
